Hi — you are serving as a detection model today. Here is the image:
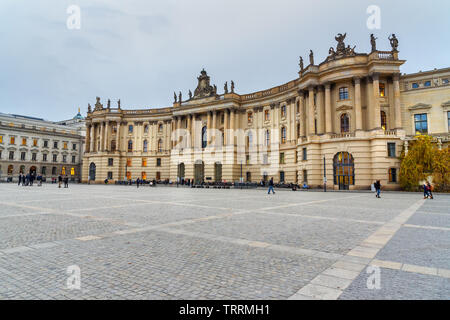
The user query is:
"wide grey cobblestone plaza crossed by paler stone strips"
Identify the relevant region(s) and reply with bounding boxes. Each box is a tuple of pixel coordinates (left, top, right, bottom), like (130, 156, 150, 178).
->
(0, 184, 450, 300)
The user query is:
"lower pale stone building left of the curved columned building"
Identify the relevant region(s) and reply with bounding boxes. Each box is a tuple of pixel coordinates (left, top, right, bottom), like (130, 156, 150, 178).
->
(0, 112, 86, 181)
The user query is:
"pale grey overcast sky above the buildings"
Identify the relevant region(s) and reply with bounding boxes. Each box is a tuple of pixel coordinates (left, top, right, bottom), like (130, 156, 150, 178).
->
(0, 0, 450, 120)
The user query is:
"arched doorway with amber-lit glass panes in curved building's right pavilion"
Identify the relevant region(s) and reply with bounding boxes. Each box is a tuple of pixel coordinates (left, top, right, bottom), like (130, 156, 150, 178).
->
(333, 152, 355, 190)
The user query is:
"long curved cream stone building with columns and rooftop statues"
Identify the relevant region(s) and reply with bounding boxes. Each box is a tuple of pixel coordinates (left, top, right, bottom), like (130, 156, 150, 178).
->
(82, 34, 450, 190)
